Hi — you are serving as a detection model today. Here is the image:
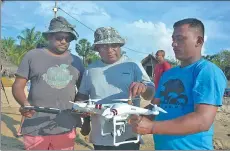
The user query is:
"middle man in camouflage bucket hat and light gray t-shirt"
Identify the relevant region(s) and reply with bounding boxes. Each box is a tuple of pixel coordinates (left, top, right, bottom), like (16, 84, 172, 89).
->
(75, 27, 154, 150)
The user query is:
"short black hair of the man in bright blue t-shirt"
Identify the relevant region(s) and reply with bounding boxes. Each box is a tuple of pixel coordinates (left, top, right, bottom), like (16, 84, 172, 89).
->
(173, 18, 205, 38)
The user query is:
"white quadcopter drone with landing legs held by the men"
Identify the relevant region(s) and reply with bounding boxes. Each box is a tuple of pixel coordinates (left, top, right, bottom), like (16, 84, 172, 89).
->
(68, 99, 167, 146)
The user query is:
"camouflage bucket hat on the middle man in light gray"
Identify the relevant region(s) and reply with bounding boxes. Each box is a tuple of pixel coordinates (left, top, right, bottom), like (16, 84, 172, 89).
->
(93, 27, 125, 49)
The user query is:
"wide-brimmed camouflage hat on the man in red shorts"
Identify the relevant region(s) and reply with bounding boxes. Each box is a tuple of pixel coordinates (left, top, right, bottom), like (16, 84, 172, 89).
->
(42, 16, 79, 40)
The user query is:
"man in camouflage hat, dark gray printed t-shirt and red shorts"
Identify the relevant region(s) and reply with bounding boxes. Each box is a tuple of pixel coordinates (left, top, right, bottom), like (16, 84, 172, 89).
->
(12, 17, 88, 150)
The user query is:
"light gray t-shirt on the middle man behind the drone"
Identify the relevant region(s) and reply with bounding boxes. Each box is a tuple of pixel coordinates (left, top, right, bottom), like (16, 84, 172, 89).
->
(79, 56, 154, 146)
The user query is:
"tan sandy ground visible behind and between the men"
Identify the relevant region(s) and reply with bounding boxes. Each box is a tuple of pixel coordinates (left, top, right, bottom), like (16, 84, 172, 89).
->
(1, 87, 230, 150)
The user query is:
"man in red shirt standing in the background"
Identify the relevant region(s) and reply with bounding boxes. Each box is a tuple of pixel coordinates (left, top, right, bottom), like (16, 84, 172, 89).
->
(153, 50, 171, 89)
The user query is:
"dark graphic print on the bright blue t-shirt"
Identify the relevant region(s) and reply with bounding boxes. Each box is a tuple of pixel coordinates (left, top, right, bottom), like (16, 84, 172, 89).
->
(160, 79, 188, 108)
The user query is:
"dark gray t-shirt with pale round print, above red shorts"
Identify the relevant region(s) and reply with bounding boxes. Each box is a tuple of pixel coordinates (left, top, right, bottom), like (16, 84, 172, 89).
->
(16, 49, 84, 136)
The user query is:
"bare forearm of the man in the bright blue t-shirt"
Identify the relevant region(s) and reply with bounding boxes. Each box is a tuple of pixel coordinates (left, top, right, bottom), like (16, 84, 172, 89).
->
(152, 112, 209, 135)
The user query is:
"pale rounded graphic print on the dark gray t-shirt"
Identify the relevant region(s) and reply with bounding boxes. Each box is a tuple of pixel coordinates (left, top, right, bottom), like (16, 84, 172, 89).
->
(42, 64, 73, 89)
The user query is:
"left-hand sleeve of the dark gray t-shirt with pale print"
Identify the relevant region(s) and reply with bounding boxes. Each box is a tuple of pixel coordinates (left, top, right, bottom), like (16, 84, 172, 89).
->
(15, 52, 31, 80)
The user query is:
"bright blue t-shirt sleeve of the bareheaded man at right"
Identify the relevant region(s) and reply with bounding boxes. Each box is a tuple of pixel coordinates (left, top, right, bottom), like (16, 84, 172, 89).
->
(192, 65, 227, 106)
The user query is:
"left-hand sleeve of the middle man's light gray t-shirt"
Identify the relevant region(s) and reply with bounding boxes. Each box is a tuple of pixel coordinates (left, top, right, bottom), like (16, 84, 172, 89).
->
(79, 70, 90, 95)
